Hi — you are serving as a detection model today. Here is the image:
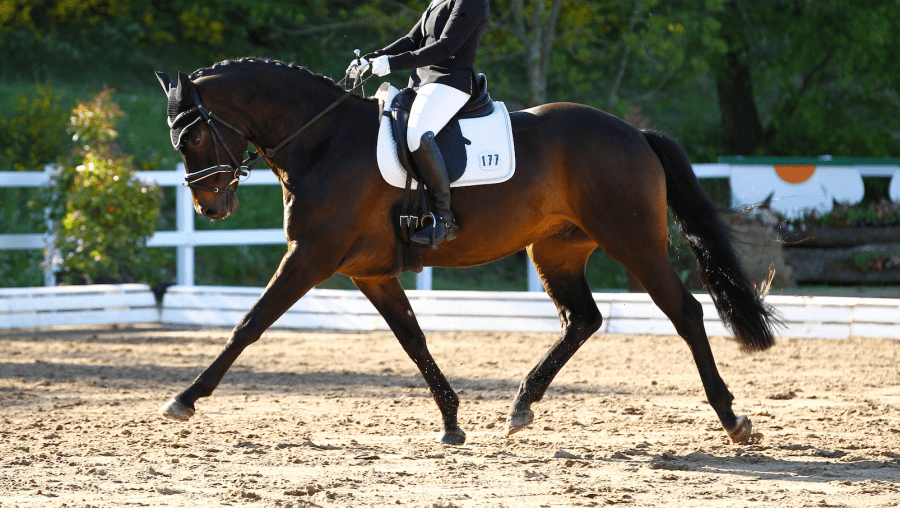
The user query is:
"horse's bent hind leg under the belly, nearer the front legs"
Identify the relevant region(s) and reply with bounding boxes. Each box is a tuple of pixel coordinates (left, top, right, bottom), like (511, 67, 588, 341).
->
(506, 236, 603, 434)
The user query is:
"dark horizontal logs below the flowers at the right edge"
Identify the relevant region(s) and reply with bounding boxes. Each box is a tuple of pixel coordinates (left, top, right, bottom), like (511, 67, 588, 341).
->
(784, 228, 900, 285)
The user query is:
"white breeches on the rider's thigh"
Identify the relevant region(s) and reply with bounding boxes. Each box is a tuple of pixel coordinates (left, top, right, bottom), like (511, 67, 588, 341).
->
(406, 83, 470, 152)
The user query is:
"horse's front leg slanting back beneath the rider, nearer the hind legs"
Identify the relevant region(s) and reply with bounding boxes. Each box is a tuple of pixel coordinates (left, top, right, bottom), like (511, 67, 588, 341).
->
(353, 277, 466, 445)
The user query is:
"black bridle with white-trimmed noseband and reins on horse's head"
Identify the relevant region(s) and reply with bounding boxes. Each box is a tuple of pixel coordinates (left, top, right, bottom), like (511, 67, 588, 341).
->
(168, 68, 375, 194)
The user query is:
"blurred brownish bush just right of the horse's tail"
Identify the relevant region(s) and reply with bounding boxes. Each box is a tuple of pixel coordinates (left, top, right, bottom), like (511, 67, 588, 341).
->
(728, 216, 797, 288)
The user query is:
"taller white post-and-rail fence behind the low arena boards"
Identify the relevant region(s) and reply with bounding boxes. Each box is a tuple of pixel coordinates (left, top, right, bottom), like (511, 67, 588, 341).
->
(0, 164, 900, 291)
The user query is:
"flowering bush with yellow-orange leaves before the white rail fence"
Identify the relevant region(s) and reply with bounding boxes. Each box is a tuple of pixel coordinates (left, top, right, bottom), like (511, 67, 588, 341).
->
(50, 90, 161, 284)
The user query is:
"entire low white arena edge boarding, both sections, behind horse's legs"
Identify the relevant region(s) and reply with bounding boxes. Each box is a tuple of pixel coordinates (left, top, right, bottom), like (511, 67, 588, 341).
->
(0, 284, 900, 339)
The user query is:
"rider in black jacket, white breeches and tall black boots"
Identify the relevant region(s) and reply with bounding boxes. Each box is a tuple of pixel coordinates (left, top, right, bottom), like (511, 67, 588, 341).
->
(347, 0, 491, 248)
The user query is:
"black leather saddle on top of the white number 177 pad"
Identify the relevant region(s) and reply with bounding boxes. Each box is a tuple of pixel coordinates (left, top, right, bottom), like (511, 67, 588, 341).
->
(376, 74, 494, 182)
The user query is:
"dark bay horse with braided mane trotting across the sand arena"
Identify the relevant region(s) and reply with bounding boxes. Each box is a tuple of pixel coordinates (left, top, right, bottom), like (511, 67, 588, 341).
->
(151, 58, 778, 444)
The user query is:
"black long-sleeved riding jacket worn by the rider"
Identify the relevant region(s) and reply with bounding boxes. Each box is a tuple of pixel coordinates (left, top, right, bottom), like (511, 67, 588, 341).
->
(366, 0, 491, 95)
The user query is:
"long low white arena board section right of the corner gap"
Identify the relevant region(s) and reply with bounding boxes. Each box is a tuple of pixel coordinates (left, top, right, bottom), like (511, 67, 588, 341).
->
(160, 286, 900, 339)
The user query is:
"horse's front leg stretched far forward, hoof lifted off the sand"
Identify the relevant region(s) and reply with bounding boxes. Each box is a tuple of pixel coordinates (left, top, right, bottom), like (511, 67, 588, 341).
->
(159, 242, 334, 420)
